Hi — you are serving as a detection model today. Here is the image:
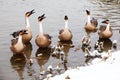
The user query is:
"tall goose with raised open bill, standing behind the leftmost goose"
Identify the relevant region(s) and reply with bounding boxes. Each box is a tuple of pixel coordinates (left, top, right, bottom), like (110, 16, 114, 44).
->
(12, 9, 35, 43)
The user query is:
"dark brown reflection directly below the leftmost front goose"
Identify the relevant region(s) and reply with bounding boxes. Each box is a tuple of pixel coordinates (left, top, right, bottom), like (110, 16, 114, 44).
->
(10, 54, 26, 80)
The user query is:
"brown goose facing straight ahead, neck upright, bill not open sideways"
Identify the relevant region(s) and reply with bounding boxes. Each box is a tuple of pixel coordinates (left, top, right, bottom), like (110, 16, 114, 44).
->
(58, 16, 73, 42)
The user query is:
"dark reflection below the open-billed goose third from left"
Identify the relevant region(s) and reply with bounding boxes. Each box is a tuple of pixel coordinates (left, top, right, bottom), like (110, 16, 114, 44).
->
(35, 47, 51, 74)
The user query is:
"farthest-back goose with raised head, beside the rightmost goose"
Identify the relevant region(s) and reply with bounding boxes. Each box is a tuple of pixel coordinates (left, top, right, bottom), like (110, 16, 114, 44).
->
(84, 10, 98, 35)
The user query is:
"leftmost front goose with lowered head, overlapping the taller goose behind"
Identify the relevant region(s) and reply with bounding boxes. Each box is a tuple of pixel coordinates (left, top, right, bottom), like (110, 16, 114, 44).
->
(10, 32, 27, 53)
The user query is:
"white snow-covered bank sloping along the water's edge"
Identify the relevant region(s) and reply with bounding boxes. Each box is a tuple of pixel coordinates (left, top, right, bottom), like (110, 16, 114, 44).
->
(44, 51, 120, 80)
